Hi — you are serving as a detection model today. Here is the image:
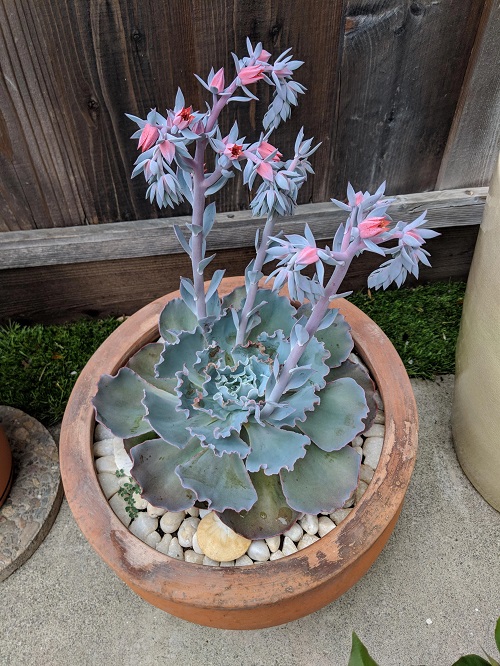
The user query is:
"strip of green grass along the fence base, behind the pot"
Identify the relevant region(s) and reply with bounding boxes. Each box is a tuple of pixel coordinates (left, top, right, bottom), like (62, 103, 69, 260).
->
(0, 282, 465, 425)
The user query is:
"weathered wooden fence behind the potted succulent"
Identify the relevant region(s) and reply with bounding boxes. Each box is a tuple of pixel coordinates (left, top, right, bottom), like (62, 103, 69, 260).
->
(0, 0, 500, 320)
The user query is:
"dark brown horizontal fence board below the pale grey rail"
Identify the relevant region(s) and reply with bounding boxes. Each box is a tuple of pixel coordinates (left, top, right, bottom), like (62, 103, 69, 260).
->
(0, 225, 479, 324)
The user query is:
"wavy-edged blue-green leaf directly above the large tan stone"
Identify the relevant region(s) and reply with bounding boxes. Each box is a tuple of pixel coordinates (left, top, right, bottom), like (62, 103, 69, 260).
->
(175, 448, 257, 511)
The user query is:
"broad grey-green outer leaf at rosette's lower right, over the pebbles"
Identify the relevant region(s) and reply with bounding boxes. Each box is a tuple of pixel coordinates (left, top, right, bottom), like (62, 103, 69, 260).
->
(280, 444, 361, 515)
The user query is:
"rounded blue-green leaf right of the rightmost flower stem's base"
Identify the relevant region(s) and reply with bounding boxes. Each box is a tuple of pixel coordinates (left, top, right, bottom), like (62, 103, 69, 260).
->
(297, 377, 368, 451)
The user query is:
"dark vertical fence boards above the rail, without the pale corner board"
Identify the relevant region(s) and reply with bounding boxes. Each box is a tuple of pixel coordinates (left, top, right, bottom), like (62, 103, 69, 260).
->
(0, 0, 492, 231)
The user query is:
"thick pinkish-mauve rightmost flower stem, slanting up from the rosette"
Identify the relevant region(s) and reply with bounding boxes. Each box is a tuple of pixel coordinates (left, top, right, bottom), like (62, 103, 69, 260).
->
(261, 241, 363, 418)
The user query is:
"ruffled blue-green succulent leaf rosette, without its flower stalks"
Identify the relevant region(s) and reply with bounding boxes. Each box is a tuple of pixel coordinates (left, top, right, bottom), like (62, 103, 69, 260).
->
(94, 288, 375, 539)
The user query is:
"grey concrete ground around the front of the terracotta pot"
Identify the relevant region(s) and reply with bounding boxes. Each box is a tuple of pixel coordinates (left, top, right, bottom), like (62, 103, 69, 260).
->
(0, 376, 500, 666)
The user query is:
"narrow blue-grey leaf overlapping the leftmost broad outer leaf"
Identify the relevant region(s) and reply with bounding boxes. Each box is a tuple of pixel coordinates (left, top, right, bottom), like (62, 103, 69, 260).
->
(142, 387, 202, 449)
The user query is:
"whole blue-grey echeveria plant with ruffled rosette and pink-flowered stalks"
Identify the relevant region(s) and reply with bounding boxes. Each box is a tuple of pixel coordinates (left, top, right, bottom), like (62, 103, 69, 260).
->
(94, 40, 437, 538)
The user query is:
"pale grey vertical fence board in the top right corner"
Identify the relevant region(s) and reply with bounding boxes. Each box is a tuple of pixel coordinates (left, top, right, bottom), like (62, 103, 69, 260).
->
(437, 0, 500, 189)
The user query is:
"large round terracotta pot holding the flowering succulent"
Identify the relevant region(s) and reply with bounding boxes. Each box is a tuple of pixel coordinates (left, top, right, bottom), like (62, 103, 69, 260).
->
(60, 278, 418, 629)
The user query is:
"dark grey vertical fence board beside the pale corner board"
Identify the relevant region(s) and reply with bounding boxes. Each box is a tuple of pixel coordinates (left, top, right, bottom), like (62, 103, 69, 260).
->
(330, 0, 484, 196)
